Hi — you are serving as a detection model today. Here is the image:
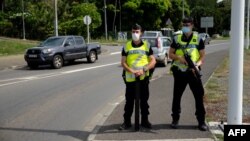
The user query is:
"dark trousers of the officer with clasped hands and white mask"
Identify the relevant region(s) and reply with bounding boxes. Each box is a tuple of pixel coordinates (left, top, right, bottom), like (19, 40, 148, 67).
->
(123, 77, 149, 122)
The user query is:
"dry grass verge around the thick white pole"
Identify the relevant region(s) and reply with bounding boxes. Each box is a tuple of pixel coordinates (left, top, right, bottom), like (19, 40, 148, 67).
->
(205, 50, 250, 140)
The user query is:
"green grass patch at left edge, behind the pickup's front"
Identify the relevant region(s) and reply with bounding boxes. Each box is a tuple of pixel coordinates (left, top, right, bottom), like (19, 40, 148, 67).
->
(0, 39, 38, 56)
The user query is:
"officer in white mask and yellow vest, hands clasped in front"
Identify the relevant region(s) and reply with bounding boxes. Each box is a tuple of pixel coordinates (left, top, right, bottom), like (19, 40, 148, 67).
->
(119, 24, 156, 130)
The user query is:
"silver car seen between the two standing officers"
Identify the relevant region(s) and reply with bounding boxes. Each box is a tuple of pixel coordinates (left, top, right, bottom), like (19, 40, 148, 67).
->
(142, 36, 172, 67)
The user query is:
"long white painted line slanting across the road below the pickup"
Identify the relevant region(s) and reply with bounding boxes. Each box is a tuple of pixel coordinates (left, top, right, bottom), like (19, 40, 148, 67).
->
(0, 62, 120, 87)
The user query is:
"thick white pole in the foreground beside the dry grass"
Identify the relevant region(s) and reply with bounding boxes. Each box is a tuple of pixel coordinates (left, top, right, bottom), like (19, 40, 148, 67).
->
(227, 0, 245, 125)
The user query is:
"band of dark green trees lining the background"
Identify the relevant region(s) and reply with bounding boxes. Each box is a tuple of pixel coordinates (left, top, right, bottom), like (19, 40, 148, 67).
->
(0, 0, 231, 40)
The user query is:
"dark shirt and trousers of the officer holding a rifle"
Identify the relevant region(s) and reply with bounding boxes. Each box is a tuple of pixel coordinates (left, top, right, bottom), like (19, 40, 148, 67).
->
(171, 32, 206, 131)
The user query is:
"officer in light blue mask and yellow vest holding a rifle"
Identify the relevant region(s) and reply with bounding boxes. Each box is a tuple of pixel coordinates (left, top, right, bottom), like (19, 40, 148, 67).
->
(169, 17, 207, 131)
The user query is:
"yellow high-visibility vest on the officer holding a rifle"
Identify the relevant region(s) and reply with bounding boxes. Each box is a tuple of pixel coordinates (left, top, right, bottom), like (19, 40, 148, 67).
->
(172, 32, 200, 72)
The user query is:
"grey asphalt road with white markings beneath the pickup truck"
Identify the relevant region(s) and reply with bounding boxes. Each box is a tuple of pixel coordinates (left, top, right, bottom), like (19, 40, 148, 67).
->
(0, 41, 229, 141)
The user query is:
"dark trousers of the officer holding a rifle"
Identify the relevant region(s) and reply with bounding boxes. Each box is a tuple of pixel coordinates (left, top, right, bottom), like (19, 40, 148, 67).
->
(172, 67, 206, 124)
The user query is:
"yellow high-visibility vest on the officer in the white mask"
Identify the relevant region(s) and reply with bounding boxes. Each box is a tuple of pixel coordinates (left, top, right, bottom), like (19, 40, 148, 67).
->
(124, 41, 149, 82)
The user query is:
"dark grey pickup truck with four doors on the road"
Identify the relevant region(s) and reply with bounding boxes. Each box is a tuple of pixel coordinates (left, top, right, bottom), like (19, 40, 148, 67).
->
(24, 35, 101, 69)
